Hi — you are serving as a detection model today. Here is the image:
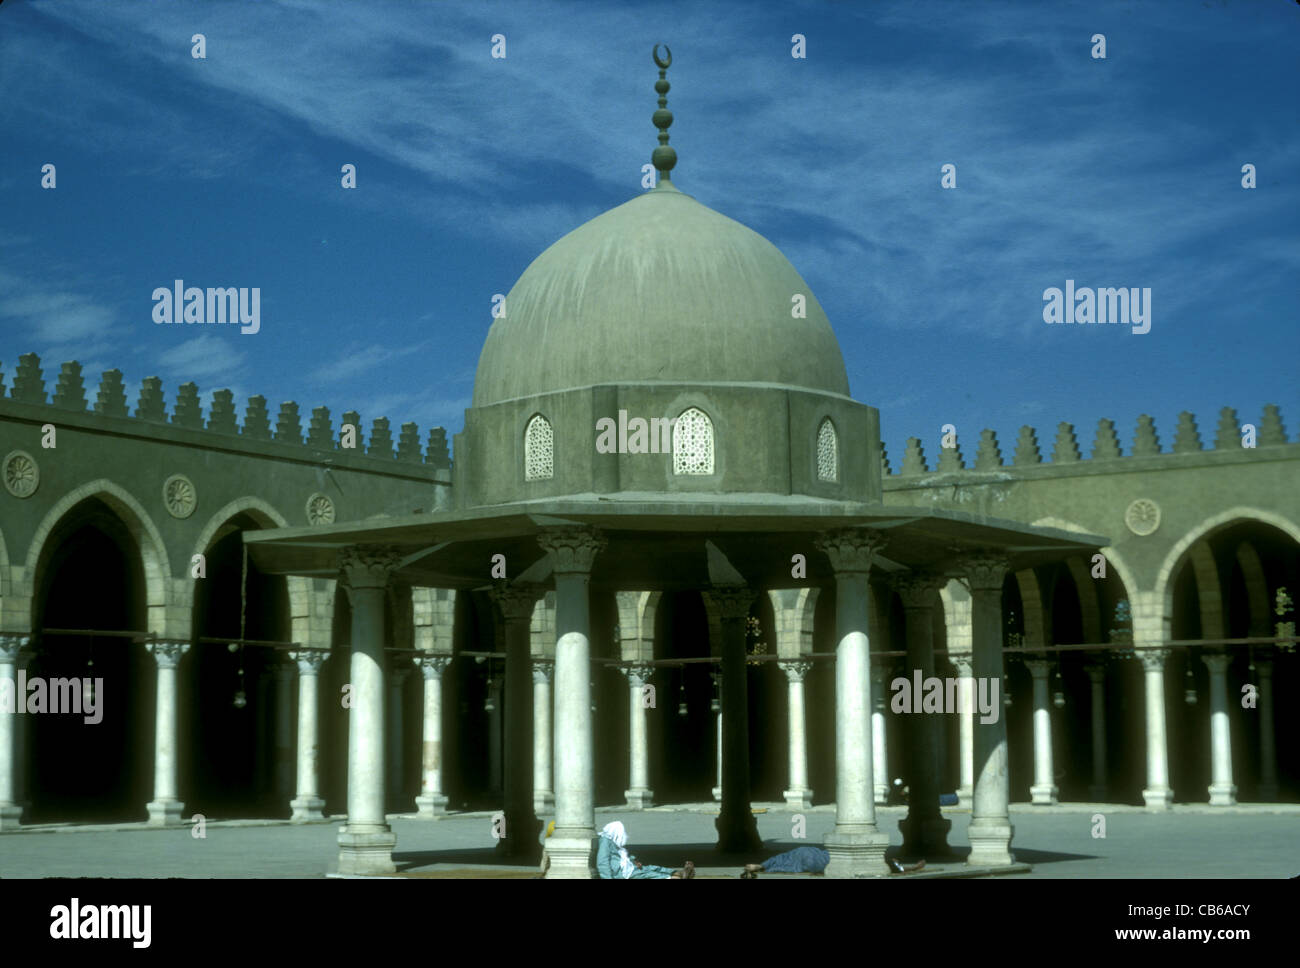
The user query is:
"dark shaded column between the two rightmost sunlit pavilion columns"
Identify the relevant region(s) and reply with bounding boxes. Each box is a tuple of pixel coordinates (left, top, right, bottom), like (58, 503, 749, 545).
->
(893, 573, 953, 856)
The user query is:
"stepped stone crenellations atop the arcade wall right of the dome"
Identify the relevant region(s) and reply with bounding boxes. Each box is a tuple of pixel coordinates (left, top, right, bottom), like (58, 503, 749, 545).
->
(880, 404, 1292, 478)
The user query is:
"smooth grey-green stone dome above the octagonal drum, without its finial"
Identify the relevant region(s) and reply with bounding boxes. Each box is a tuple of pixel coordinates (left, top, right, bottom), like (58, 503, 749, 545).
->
(473, 182, 849, 407)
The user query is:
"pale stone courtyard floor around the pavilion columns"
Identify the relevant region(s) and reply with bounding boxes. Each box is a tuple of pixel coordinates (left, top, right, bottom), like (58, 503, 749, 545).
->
(0, 803, 1300, 880)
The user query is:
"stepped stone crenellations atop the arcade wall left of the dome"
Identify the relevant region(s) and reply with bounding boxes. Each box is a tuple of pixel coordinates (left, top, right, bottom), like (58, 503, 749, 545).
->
(0, 353, 451, 470)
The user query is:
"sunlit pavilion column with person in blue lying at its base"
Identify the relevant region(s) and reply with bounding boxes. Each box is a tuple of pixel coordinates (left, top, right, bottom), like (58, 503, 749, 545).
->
(816, 529, 889, 877)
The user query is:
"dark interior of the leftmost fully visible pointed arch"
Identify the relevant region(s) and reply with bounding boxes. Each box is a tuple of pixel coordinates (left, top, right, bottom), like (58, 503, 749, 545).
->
(28, 499, 155, 824)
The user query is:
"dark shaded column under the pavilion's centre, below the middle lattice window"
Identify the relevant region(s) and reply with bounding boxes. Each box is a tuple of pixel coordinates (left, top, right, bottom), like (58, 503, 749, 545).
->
(709, 585, 763, 852)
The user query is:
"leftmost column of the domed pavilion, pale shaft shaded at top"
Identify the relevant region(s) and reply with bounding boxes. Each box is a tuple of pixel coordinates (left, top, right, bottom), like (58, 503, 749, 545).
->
(338, 546, 400, 874)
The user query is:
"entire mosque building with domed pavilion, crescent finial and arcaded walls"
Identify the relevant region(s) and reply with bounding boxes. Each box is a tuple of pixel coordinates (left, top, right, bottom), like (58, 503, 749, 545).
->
(0, 53, 1300, 877)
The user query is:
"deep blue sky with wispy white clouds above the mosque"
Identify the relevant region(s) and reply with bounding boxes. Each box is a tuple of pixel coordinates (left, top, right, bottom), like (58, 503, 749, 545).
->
(0, 0, 1300, 470)
